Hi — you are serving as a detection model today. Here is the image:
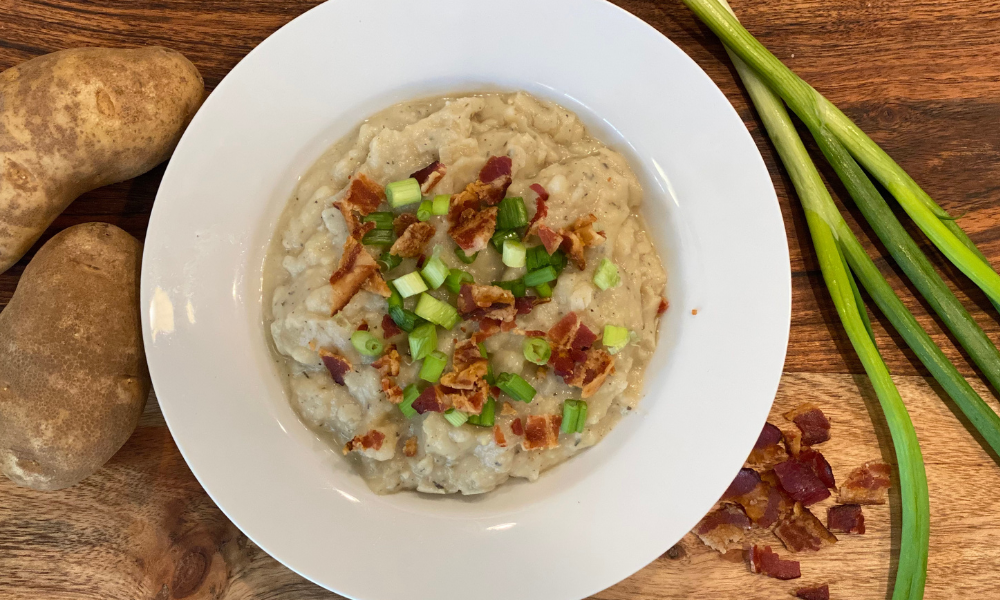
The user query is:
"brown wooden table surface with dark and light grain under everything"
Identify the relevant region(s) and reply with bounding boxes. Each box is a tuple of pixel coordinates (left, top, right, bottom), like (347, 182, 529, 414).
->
(0, 0, 1000, 600)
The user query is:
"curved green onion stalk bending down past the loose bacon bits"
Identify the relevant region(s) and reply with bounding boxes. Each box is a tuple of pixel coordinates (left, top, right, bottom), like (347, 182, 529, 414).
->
(712, 14, 930, 600)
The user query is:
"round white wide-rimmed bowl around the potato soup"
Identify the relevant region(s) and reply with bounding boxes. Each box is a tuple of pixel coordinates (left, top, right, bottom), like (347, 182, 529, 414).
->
(142, 0, 791, 600)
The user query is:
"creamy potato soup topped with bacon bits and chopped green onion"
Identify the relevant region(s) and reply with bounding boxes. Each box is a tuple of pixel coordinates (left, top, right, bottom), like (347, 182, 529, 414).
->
(264, 93, 667, 494)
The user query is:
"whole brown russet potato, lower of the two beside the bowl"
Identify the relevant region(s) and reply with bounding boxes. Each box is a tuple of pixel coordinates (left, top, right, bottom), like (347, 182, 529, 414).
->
(0, 223, 150, 490)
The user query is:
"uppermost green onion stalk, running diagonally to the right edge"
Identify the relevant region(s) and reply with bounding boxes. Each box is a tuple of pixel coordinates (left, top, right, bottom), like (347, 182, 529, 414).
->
(683, 0, 1000, 310)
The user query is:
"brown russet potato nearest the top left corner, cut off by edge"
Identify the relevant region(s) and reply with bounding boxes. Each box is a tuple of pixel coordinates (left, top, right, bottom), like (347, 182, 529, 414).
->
(0, 47, 205, 273)
